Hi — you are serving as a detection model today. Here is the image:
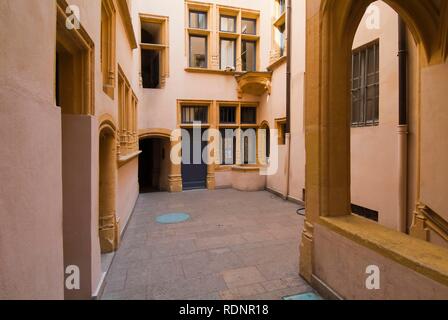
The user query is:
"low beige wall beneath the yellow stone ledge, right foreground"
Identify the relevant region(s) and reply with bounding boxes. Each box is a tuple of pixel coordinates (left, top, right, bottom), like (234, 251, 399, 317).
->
(314, 225, 448, 300)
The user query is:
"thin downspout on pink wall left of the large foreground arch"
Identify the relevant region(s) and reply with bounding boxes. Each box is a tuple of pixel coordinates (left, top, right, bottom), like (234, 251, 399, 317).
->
(285, 0, 292, 199)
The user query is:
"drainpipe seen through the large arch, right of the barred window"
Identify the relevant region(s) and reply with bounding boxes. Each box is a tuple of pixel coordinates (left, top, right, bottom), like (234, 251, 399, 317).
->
(398, 18, 409, 233)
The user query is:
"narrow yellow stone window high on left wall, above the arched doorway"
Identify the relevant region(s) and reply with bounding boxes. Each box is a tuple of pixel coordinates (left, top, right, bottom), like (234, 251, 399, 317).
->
(101, 0, 116, 99)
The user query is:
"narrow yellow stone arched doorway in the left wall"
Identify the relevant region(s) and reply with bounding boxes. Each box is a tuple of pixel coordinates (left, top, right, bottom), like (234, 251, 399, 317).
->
(98, 124, 120, 253)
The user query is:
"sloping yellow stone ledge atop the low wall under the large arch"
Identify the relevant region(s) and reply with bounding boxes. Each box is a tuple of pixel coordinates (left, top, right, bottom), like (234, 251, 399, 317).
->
(319, 215, 448, 286)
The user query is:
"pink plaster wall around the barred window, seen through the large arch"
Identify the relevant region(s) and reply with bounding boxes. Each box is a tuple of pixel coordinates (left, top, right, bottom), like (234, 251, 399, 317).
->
(351, 2, 399, 229)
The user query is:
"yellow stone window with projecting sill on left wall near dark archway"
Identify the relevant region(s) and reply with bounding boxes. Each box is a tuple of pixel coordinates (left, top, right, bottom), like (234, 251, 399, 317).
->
(118, 67, 138, 156)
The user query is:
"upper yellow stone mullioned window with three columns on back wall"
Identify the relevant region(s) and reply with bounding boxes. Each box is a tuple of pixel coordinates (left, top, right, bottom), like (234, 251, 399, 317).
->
(185, 0, 260, 73)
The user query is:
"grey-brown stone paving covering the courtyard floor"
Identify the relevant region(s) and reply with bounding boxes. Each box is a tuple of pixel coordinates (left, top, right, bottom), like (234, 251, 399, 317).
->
(102, 189, 312, 300)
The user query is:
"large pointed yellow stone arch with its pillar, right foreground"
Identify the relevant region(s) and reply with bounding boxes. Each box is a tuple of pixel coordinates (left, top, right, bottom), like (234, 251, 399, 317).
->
(300, 0, 447, 280)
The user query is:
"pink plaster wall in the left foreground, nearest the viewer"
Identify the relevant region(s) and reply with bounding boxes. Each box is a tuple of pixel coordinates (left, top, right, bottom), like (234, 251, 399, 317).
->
(0, 0, 64, 299)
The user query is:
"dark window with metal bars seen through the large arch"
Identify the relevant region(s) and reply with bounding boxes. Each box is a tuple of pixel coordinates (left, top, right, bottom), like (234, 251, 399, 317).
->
(352, 41, 379, 127)
